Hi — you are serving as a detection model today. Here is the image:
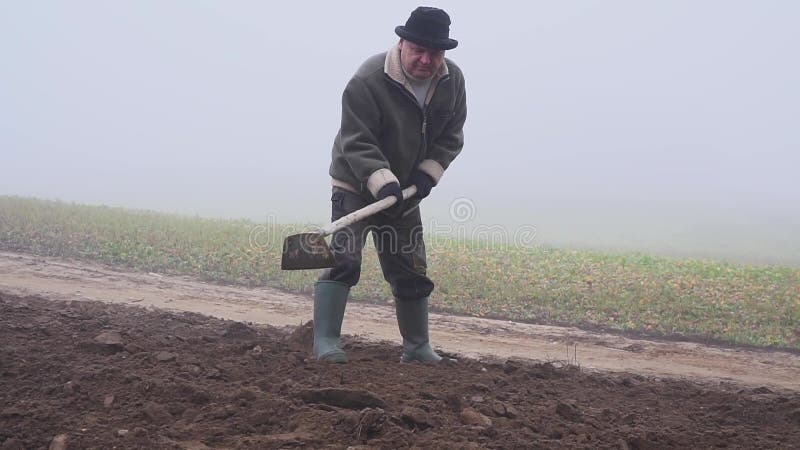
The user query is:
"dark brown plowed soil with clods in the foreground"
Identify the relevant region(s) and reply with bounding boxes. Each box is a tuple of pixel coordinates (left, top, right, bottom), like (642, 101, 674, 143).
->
(0, 294, 800, 449)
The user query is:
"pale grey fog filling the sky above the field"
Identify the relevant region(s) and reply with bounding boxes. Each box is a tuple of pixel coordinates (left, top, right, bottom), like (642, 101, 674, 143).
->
(0, 0, 800, 264)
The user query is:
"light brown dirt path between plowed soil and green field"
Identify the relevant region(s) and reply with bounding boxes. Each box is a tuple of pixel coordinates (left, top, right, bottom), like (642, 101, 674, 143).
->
(0, 252, 800, 390)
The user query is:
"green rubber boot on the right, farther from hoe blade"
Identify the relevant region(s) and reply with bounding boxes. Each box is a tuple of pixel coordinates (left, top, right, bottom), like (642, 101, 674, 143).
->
(395, 297, 442, 364)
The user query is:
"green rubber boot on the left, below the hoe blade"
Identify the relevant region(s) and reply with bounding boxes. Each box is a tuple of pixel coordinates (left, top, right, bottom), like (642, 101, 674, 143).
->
(314, 281, 350, 363)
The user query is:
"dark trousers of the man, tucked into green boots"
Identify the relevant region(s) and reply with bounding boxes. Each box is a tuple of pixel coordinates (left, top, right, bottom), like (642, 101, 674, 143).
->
(319, 187, 433, 300)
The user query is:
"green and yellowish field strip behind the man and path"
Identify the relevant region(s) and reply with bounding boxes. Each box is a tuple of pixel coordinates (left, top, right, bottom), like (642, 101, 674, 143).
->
(0, 196, 800, 350)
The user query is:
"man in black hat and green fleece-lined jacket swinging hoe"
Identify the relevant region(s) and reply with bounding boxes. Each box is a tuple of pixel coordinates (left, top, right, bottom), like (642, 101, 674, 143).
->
(314, 7, 466, 363)
